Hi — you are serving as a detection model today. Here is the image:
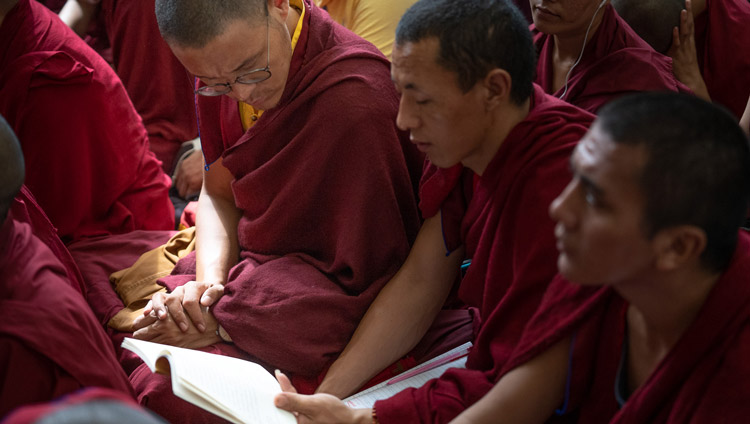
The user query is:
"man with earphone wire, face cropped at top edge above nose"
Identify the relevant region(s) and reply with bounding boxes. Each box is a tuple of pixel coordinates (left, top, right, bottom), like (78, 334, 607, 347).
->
(530, 0, 689, 113)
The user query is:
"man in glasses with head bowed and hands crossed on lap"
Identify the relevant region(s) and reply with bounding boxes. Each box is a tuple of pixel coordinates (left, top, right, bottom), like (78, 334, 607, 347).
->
(126, 0, 423, 422)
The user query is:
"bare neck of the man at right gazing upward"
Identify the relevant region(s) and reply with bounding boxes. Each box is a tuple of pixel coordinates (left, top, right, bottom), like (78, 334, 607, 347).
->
(616, 264, 720, 350)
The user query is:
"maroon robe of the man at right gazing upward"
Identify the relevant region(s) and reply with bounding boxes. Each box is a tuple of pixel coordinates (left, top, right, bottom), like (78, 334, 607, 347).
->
(507, 231, 750, 424)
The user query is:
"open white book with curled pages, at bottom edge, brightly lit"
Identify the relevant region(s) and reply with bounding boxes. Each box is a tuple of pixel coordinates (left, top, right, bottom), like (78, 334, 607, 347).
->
(122, 338, 297, 424)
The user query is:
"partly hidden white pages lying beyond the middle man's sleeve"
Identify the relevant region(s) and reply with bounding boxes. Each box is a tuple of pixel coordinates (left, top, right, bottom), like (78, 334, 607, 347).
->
(344, 342, 472, 408)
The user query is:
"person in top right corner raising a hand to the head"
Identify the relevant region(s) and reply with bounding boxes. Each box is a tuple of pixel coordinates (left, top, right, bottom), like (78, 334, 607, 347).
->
(613, 0, 750, 119)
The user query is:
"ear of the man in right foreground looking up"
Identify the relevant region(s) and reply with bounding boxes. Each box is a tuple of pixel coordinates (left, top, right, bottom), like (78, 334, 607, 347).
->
(653, 225, 706, 271)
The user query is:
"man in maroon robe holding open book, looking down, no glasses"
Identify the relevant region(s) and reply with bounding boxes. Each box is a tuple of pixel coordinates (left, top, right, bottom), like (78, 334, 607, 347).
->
(278, 0, 592, 423)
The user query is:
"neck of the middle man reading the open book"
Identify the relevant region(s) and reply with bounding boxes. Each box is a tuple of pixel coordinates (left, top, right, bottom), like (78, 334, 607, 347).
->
(461, 93, 534, 176)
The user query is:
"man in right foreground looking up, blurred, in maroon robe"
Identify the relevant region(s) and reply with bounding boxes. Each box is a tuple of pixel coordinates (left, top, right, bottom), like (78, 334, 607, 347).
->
(456, 94, 750, 423)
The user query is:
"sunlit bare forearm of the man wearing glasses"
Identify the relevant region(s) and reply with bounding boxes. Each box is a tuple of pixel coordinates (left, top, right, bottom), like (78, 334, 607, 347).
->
(195, 190, 241, 284)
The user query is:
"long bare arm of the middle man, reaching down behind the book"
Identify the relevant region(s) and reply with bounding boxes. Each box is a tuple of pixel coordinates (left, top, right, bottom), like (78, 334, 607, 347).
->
(318, 214, 463, 398)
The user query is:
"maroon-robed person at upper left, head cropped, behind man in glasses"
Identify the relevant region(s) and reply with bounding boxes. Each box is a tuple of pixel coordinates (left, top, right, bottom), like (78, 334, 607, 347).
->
(60, 0, 203, 198)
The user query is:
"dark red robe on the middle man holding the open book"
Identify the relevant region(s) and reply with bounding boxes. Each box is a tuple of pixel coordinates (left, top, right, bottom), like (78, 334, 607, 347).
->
(375, 86, 593, 424)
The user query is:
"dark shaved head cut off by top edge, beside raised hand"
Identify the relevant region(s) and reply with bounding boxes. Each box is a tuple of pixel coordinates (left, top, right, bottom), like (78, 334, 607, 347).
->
(612, 0, 685, 54)
